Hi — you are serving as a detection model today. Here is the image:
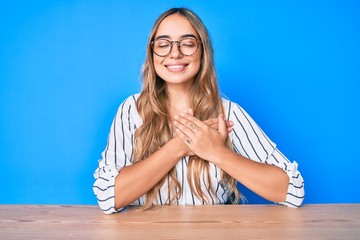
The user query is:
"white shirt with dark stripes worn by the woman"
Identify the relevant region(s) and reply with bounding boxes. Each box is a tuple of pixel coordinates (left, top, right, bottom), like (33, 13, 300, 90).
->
(93, 94, 304, 214)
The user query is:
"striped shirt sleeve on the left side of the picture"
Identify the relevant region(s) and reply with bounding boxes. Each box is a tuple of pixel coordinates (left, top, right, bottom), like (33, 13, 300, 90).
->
(93, 94, 136, 214)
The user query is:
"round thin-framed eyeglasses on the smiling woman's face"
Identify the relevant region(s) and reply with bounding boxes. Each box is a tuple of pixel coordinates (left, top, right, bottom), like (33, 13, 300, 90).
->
(151, 38, 201, 57)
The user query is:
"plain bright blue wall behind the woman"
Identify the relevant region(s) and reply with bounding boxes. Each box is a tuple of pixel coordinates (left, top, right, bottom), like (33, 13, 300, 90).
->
(0, 0, 360, 204)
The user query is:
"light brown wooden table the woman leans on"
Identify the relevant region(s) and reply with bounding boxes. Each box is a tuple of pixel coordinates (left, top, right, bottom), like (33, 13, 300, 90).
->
(0, 204, 360, 240)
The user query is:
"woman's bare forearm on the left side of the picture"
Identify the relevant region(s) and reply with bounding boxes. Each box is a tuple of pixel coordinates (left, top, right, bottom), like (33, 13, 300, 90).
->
(115, 138, 186, 209)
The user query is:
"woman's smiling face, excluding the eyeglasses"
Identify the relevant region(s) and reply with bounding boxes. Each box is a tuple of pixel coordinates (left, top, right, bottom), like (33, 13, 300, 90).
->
(153, 14, 202, 86)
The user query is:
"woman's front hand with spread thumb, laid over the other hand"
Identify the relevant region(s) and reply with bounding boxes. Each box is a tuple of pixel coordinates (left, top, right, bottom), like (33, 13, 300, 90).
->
(174, 110, 228, 161)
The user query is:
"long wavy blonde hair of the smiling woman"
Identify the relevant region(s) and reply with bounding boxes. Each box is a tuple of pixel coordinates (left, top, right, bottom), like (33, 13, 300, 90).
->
(134, 8, 240, 209)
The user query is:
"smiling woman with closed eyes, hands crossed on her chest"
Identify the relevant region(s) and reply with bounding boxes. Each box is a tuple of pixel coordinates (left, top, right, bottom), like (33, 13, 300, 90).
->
(93, 8, 304, 213)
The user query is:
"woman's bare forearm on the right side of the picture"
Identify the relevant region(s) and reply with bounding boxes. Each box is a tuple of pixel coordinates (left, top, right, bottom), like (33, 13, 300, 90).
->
(212, 147, 289, 202)
